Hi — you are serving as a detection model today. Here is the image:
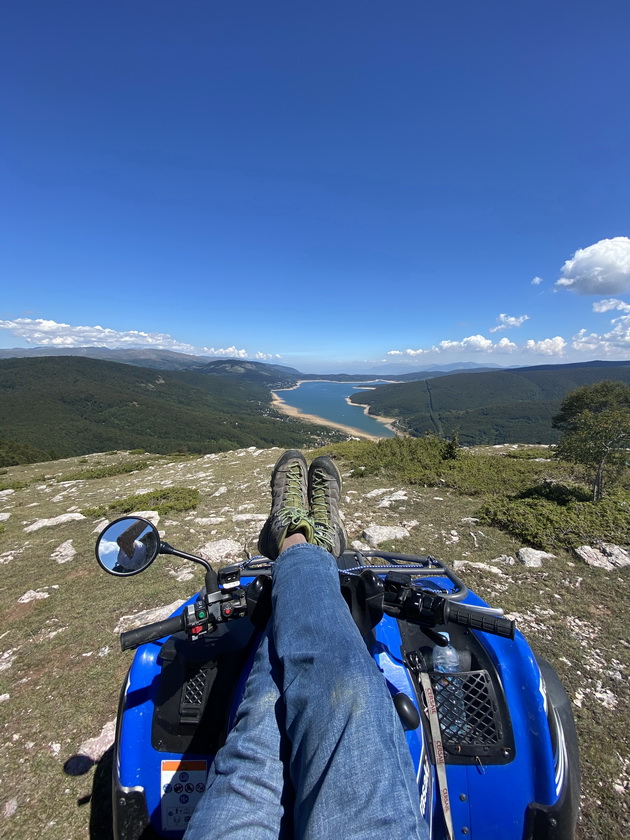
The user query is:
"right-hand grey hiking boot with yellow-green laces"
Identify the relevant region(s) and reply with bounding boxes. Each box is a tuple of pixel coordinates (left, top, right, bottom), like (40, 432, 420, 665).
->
(308, 455, 348, 557)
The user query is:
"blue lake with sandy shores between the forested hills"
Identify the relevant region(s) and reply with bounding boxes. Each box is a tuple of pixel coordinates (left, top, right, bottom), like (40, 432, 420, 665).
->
(274, 380, 395, 437)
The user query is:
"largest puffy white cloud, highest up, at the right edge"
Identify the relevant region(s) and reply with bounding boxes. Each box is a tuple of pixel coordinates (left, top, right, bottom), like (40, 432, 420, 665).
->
(556, 236, 630, 295)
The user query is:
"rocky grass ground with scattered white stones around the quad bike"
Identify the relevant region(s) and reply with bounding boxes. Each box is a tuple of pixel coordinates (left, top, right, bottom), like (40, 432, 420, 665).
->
(0, 442, 630, 840)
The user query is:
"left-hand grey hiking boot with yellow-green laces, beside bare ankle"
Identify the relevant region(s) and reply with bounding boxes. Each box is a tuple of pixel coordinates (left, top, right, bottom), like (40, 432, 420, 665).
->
(258, 449, 314, 560)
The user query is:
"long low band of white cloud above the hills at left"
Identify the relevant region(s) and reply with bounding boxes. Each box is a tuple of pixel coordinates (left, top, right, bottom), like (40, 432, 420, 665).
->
(0, 318, 280, 359)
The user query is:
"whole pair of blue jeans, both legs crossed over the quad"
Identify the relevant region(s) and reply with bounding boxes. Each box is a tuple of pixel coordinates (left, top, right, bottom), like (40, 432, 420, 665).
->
(185, 543, 429, 840)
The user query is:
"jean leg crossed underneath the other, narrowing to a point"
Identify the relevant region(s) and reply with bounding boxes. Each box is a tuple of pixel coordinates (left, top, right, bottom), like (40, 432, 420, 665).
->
(185, 628, 293, 840)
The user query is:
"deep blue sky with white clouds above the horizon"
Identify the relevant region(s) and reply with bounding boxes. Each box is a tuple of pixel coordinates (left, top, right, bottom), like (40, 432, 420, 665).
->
(0, 0, 630, 371)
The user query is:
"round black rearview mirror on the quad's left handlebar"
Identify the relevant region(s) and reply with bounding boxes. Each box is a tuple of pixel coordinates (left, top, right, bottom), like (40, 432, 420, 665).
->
(96, 516, 160, 576)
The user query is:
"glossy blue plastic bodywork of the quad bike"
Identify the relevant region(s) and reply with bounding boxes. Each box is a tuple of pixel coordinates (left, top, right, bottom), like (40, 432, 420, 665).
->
(117, 578, 558, 840)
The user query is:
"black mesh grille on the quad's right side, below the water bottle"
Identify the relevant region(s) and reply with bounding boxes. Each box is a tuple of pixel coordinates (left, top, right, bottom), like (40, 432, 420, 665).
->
(431, 671, 503, 755)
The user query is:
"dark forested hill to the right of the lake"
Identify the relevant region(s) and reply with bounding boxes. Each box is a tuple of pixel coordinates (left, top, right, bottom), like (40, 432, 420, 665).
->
(352, 362, 630, 444)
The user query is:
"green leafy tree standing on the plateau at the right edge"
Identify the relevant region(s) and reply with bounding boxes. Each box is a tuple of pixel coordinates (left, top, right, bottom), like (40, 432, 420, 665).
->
(553, 380, 630, 502)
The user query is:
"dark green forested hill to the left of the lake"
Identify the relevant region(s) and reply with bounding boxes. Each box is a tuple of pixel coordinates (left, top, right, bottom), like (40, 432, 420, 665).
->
(0, 357, 339, 460)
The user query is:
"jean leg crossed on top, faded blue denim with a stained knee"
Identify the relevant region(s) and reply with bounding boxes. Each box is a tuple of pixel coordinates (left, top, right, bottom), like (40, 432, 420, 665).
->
(272, 543, 429, 840)
